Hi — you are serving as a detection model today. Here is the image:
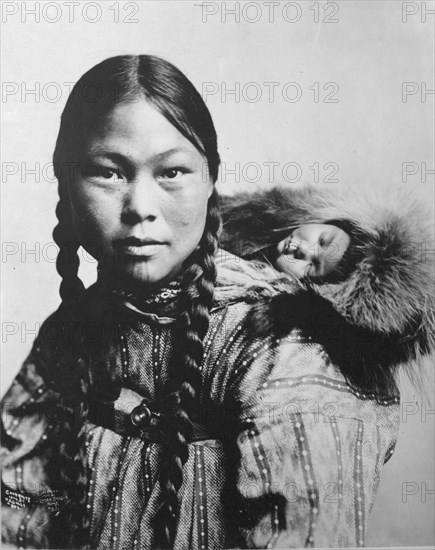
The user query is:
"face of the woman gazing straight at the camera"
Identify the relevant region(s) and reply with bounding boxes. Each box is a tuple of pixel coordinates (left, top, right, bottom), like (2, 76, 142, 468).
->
(69, 99, 213, 288)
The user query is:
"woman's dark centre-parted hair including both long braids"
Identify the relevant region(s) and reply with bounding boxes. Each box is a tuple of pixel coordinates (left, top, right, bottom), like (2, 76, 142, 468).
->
(53, 55, 220, 548)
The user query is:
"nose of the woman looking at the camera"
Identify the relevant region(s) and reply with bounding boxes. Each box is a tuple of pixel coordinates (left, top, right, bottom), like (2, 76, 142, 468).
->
(122, 177, 159, 225)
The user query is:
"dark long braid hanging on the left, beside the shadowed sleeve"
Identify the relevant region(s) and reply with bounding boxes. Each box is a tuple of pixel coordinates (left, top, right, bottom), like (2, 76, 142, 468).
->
(52, 180, 89, 548)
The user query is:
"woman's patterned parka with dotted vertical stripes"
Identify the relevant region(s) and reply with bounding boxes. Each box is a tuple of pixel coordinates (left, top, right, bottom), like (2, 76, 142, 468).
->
(1, 184, 433, 550)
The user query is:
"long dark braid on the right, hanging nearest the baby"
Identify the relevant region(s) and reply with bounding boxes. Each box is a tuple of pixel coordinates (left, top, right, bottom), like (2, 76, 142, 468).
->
(155, 192, 220, 548)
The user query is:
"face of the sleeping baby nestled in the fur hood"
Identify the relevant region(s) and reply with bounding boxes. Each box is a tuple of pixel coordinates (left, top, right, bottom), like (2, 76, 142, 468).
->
(274, 223, 350, 281)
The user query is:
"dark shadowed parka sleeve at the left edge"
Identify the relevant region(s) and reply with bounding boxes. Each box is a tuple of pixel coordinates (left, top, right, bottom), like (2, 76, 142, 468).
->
(0, 325, 64, 548)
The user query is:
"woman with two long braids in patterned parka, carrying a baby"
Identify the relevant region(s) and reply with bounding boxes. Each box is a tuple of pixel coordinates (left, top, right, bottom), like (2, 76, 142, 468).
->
(2, 56, 430, 549)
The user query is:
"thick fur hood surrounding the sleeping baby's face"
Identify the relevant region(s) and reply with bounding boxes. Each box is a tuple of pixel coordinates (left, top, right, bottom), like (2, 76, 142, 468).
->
(221, 186, 435, 394)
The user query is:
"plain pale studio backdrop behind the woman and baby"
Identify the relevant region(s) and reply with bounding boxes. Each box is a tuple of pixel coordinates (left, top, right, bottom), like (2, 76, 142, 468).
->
(2, 0, 435, 547)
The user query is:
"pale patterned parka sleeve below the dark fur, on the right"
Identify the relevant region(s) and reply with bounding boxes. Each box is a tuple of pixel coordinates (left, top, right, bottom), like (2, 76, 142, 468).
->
(234, 334, 398, 548)
